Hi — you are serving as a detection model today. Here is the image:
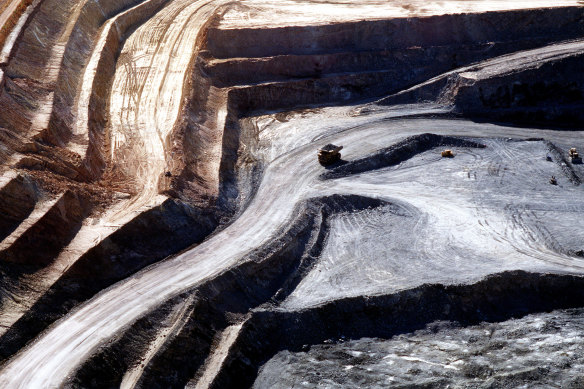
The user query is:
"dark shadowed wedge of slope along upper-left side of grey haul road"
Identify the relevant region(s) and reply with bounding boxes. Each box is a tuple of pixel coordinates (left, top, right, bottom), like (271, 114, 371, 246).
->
(0, 199, 220, 361)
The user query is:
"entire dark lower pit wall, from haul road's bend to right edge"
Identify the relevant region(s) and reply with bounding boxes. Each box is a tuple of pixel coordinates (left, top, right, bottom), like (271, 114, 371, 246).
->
(60, 195, 584, 388)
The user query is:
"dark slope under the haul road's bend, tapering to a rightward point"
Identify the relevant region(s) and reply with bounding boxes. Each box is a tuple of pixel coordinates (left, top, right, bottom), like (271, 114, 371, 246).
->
(62, 195, 388, 388)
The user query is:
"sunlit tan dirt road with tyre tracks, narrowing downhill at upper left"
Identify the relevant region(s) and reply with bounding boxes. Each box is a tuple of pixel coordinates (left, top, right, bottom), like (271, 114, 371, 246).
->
(110, 1, 227, 213)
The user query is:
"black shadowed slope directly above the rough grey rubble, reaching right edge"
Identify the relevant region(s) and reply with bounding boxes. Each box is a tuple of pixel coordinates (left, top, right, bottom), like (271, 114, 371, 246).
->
(212, 271, 584, 388)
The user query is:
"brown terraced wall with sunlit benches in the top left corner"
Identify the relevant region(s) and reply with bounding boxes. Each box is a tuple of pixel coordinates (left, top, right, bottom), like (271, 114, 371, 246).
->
(0, 0, 163, 181)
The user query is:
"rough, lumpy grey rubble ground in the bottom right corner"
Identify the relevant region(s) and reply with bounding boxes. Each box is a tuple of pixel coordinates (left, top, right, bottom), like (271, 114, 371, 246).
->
(254, 309, 584, 389)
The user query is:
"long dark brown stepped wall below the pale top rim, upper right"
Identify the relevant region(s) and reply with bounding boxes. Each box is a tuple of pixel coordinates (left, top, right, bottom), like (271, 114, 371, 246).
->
(198, 7, 584, 209)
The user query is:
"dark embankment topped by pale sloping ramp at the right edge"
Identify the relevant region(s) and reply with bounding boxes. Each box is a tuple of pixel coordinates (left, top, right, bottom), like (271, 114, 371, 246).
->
(378, 39, 584, 126)
